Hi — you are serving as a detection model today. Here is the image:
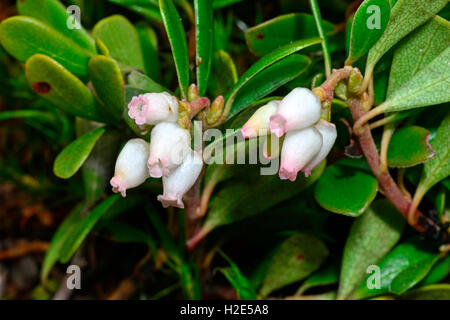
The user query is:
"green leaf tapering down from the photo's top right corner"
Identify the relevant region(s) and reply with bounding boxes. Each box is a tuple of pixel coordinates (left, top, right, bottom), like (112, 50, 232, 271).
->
(366, 0, 448, 75)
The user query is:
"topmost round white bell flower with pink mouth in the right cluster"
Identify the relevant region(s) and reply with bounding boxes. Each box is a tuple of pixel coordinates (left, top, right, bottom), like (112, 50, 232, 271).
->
(269, 88, 321, 137)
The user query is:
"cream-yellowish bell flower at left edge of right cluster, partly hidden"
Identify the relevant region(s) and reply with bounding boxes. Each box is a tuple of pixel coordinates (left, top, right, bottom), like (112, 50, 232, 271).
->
(241, 100, 280, 138)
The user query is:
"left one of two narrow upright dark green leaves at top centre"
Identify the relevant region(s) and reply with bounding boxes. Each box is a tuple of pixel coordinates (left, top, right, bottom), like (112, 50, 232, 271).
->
(159, 0, 189, 99)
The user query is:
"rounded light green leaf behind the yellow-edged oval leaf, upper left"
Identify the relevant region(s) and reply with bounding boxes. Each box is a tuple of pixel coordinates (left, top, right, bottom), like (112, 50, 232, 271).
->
(92, 15, 145, 70)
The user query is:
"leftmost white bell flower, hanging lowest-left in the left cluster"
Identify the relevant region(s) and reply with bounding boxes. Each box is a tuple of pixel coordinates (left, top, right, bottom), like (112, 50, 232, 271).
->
(110, 139, 150, 197)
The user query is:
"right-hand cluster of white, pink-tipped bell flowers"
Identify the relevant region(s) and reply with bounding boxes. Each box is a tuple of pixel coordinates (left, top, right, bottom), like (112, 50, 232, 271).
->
(241, 88, 337, 181)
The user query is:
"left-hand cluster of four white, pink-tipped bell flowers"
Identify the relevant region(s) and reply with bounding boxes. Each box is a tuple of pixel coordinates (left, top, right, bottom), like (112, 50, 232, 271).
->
(110, 92, 203, 208)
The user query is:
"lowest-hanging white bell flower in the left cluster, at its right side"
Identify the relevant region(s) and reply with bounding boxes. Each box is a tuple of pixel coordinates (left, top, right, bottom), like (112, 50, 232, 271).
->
(158, 150, 203, 208)
